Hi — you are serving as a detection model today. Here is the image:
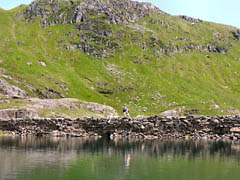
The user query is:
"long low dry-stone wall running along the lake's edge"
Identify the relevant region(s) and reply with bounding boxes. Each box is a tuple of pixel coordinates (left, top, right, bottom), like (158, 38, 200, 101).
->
(0, 116, 240, 139)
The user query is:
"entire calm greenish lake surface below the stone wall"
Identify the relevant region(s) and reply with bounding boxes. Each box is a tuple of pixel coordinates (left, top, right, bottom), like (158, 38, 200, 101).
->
(0, 137, 240, 180)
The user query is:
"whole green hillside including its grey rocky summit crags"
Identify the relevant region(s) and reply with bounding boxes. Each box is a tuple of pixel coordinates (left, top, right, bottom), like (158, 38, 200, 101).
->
(0, 0, 240, 115)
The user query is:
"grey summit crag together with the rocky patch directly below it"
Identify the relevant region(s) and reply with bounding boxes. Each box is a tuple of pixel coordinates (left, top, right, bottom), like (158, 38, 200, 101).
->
(25, 0, 163, 58)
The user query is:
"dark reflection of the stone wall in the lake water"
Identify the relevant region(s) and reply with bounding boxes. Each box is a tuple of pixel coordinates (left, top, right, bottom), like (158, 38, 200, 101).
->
(0, 137, 240, 159)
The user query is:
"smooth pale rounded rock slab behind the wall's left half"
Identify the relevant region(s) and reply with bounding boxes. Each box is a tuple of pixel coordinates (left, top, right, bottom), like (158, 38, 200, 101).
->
(0, 98, 118, 120)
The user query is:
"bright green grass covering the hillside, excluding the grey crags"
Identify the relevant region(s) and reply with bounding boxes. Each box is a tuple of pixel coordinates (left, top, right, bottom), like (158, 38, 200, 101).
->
(0, 2, 240, 116)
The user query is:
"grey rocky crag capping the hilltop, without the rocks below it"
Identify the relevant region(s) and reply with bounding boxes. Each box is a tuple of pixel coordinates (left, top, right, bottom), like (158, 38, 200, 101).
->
(26, 0, 162, 25)
